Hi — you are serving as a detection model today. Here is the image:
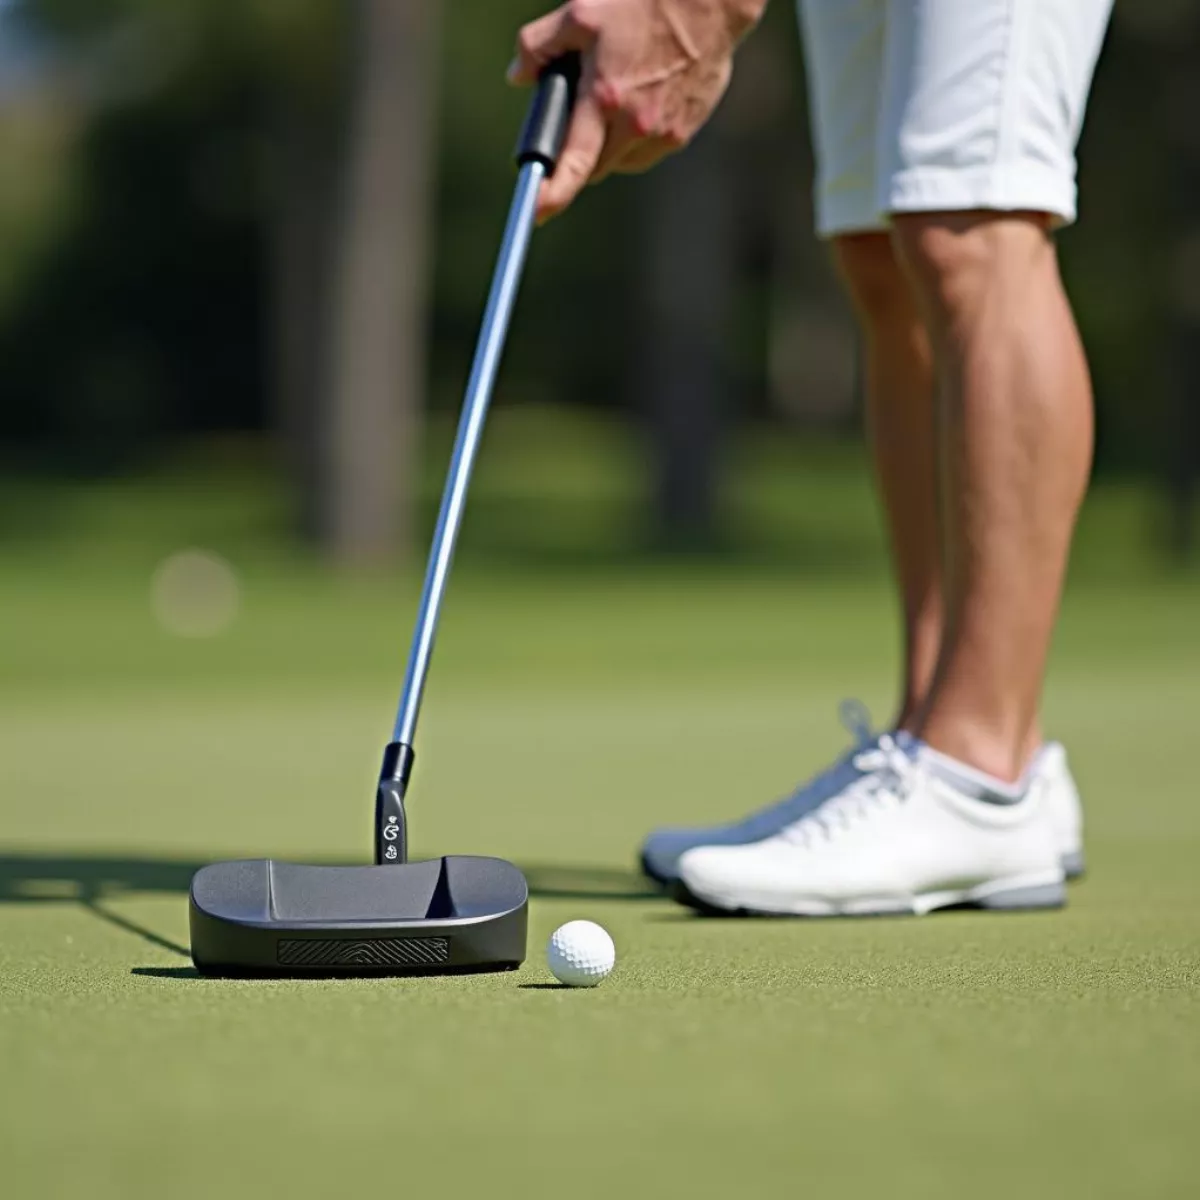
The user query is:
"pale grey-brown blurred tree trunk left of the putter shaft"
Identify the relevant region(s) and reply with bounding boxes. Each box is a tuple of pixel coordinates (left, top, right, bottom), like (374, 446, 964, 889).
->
(319, 0, 438, 565)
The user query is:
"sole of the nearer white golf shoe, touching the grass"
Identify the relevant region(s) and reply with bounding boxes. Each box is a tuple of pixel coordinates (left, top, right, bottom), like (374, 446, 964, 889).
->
(673, 872, 1067, 919)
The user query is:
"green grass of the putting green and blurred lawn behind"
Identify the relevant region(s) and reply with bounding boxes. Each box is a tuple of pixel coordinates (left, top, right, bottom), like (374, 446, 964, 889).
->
(0, 421, 1200, 1200)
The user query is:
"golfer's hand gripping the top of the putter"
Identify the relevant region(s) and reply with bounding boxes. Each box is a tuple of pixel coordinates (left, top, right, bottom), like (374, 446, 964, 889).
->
(509, 0, 767, 221)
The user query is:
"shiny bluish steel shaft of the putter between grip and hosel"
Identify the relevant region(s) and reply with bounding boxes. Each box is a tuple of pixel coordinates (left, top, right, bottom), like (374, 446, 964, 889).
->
(392, 154, 546, 746)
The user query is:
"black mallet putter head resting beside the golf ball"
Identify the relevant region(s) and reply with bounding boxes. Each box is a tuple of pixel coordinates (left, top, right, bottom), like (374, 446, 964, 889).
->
(190, 856, 529, 976)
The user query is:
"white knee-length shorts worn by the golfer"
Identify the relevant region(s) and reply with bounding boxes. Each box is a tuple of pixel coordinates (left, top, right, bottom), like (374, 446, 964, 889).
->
(799, 0, 1112, 236)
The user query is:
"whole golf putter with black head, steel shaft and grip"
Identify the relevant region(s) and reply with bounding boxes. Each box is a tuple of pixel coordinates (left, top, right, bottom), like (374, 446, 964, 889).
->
(190, 55, 580, 976)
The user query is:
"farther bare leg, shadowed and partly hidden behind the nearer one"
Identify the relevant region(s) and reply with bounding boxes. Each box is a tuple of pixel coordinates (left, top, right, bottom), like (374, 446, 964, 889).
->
(833, 233, 942, 726)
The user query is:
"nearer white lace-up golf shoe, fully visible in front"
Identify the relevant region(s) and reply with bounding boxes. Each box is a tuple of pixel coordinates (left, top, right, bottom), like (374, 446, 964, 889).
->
(679, 737, 1078, 917)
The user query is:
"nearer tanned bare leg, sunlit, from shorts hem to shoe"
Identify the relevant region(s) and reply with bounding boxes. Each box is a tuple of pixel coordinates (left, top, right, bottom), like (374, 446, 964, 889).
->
(894, 212, 1093, 780)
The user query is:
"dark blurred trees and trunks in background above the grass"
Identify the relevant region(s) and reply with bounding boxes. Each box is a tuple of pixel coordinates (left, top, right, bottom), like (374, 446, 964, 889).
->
(0, 0, 1200, 563)
